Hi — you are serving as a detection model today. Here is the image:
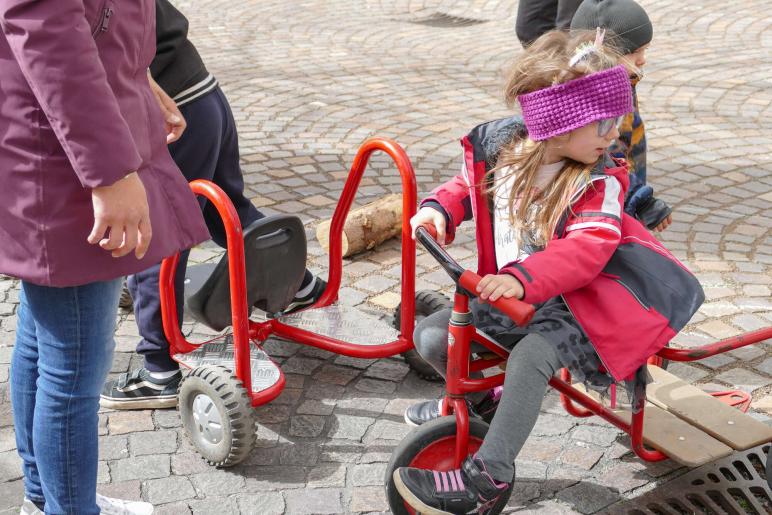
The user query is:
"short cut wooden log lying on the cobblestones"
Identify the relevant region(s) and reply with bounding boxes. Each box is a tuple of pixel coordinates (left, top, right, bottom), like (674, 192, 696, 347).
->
(316, 194, 402, 257)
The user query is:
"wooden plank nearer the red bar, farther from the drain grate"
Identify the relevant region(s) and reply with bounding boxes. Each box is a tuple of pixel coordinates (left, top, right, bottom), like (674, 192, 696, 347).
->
(646, 365, 772, 450)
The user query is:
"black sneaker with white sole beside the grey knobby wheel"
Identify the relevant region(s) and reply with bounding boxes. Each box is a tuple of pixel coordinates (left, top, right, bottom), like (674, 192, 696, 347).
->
(99, 368, 182, 409)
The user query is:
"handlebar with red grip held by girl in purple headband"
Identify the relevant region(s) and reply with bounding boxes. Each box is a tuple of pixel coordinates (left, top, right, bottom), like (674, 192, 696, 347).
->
(415, 229, 534, 326)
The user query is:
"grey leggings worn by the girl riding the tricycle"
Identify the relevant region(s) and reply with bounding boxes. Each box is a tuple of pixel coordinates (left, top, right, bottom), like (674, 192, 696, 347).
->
(414, 309, 563, 483)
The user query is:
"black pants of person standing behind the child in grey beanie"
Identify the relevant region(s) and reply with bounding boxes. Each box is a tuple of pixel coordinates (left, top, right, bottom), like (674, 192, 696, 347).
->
(515, 0, 582, 46)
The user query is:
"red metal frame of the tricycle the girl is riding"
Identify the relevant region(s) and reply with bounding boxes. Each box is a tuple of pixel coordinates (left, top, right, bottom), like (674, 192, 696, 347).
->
(434, 293, 772, 468)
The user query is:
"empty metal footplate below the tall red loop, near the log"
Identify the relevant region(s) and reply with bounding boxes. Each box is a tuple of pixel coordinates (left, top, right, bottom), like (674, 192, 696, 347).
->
(278, 304, 399, 347)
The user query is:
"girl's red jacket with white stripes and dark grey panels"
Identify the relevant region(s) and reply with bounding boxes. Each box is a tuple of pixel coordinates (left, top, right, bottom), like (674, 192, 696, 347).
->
(422, 117, 704, 380)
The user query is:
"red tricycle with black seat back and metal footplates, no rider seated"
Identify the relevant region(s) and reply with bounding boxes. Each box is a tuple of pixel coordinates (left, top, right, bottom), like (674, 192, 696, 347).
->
(160, 138, 444, 467)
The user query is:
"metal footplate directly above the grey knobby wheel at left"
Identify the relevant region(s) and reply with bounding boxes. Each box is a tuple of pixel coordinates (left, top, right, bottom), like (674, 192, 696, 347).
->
(174, 334, 281, 393)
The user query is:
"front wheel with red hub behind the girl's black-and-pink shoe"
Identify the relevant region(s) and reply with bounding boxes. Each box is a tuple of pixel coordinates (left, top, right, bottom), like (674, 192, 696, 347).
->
(383, 416, 515, 515)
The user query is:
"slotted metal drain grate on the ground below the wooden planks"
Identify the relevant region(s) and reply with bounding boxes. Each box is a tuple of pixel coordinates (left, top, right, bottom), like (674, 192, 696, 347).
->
(608, 444, 772, 515)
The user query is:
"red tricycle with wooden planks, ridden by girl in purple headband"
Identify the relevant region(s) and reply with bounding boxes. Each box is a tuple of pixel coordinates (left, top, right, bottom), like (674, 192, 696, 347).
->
(384, 227, 772, 514)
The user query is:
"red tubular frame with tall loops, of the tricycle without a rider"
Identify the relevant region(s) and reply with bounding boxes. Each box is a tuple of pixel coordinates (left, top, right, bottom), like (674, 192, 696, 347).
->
(160, 138, 418, 406)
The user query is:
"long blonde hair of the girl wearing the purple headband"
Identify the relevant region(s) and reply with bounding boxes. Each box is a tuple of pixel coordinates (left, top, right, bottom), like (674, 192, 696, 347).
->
(492, 31, 620, 245)
